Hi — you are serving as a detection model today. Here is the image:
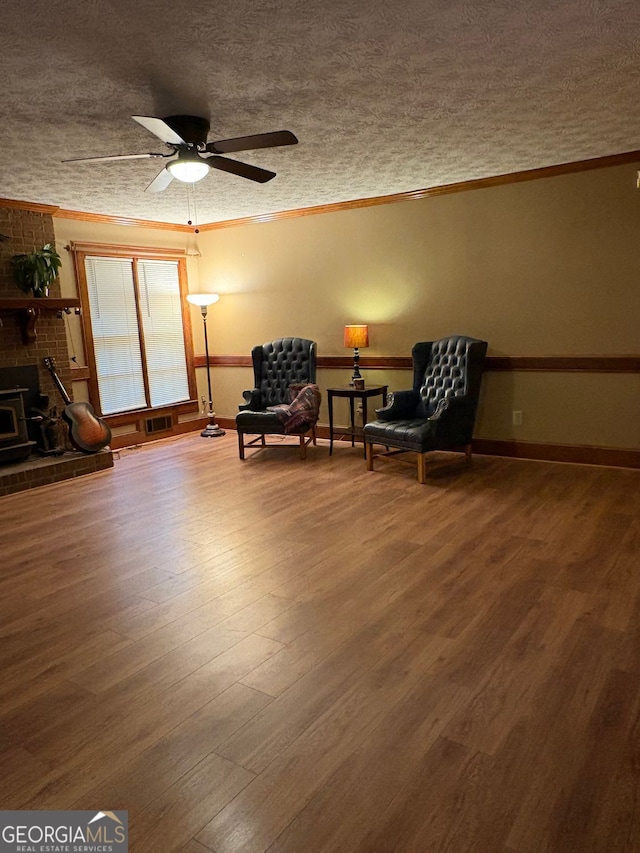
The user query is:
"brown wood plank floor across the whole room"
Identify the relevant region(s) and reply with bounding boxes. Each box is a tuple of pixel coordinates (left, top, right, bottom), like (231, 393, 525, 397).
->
(0, 433, 640, 853)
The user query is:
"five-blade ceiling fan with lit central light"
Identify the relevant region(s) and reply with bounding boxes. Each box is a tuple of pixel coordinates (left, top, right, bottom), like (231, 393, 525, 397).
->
(62, 116, 298, 193)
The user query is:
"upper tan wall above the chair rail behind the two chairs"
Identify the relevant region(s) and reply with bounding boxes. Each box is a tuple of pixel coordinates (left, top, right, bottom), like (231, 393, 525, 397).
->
(199, 164, 640, 355)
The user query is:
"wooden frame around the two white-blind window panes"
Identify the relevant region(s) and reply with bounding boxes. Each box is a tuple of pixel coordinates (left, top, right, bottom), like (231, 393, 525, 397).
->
(69, 243, 198, 423)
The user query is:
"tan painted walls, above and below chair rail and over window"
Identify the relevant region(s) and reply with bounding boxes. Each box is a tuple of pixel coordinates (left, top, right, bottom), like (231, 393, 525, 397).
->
(54, 164, 640, 448)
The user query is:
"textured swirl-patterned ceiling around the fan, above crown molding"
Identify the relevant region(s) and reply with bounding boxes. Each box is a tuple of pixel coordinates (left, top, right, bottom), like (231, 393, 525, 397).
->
(0, 0, 640, 223)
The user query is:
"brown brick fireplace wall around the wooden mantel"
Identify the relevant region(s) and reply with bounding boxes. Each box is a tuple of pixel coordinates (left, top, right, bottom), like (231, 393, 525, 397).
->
(0, 207, 72, 406)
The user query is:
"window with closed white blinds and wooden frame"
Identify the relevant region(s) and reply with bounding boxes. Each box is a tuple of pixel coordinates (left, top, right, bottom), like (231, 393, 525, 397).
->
(76, 247, 194, 415)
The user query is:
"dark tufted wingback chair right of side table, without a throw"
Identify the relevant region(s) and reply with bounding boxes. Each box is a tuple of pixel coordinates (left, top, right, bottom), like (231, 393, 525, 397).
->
(364, 335, 487, 483)
